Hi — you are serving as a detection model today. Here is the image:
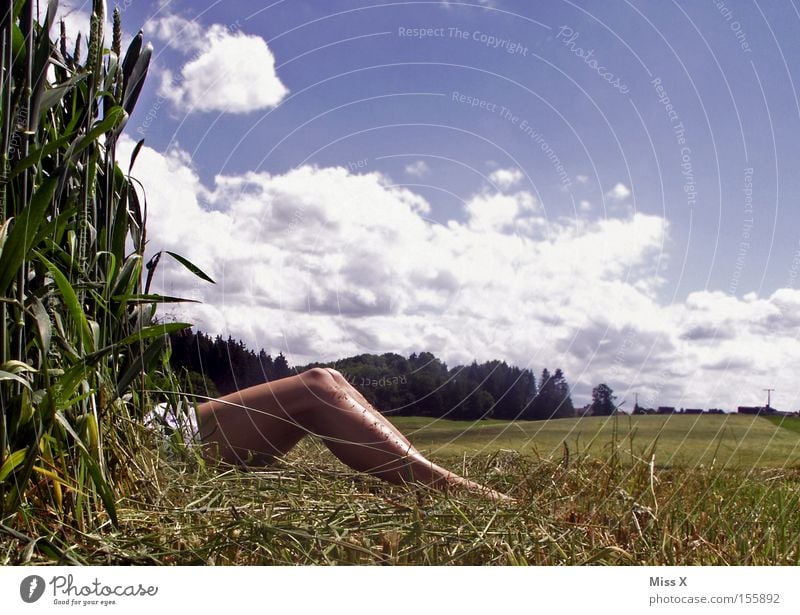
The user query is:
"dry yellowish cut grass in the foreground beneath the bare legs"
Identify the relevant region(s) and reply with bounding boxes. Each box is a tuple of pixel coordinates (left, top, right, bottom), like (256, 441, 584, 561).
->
(0, 442, 800, 565)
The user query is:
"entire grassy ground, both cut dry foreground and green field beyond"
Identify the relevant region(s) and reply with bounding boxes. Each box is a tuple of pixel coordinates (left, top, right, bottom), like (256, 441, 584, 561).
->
(6, 416, 800, 565)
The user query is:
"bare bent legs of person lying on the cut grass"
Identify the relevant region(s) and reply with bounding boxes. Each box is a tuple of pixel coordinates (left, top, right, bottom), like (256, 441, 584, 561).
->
(198, 368, 510, 500)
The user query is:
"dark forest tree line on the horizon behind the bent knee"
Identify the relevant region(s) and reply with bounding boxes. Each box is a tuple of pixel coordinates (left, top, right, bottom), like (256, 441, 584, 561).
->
(171, 331, 575, 420)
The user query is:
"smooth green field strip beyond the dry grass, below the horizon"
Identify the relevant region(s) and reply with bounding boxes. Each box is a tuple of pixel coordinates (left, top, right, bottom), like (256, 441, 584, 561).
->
(392, 414, 800, 470)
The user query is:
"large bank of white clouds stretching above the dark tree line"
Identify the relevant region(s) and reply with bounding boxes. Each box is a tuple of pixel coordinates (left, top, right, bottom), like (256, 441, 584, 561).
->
(120, 139, 800, 408)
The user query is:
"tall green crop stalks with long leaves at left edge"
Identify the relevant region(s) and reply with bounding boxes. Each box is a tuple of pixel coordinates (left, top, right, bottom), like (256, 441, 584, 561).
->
(0, 0, 202, 530)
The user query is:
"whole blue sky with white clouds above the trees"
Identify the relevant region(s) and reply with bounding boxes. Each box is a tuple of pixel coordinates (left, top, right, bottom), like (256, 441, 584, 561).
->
(63, 0, 800, 410)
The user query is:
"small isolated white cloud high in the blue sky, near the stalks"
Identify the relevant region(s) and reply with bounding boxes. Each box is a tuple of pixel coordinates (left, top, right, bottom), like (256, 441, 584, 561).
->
(150, 15, 289, 113)
